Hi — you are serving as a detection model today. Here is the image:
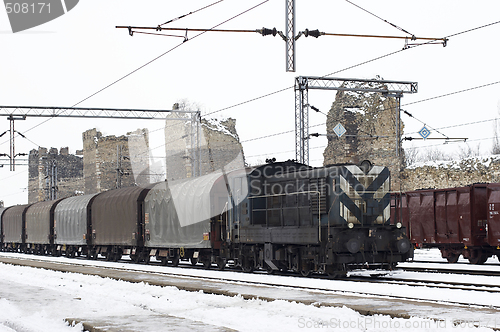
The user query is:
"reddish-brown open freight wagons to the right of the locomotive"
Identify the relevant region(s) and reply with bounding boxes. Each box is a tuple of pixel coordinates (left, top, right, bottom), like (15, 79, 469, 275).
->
(391, 183, 500, 264)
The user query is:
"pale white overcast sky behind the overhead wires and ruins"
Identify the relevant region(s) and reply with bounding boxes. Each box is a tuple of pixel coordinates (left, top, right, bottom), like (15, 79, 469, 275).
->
(0, 0, 500, 205)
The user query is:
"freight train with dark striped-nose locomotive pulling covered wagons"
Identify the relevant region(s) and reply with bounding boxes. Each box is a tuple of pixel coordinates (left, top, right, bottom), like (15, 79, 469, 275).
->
(0, 161, 413, 277)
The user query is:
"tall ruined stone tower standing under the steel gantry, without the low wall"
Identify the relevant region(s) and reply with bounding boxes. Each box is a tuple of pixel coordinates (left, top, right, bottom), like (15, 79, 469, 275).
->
(323, 82, 404, 190)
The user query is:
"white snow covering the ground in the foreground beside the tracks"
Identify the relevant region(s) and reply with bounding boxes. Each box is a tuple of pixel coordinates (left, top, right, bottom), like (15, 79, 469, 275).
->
(0, 253, 500, 332)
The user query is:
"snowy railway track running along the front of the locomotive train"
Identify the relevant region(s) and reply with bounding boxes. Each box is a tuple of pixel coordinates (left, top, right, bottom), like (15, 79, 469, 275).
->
(0, 255, 500, 310)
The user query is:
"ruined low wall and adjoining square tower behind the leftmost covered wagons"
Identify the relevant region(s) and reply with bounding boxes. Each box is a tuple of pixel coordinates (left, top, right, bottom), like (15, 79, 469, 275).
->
(28, 129, 149, 203)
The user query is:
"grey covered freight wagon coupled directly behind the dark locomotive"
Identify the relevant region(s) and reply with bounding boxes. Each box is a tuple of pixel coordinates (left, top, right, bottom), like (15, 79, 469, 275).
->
(144, 172, 229, 265)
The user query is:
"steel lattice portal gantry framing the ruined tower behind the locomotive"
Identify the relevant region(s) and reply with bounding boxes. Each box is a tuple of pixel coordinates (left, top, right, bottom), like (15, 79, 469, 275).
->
(295, 76, 418, 165)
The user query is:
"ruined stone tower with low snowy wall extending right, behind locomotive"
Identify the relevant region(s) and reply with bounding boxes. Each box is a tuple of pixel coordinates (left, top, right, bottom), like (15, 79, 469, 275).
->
(323, 80, 500, 191)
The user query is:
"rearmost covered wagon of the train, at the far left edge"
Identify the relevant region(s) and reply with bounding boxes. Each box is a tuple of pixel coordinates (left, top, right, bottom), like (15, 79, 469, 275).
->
(2, 204, 30, 251)
